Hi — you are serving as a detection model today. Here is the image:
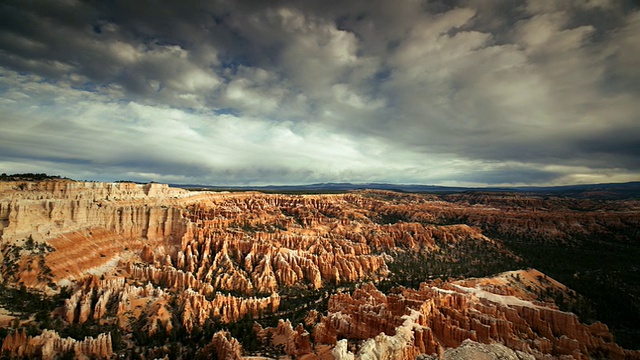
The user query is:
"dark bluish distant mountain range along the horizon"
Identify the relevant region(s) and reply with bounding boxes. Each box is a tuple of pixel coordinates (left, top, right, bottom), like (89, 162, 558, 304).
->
(171, 181, 640, 199)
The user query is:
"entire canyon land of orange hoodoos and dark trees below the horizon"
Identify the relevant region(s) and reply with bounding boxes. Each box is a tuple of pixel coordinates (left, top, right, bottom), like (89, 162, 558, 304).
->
(0, 179, 640, 359)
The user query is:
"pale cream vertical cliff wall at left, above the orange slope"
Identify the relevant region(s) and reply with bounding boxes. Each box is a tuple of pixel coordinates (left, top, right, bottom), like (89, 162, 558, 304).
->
(0, 181, 190, 242)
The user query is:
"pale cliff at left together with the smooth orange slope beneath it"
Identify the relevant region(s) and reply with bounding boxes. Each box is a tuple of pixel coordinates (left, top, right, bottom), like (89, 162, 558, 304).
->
(0, 181, 190, 286)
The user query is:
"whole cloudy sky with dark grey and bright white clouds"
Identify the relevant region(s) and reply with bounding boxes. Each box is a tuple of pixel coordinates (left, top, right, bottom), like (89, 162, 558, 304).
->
(0, 0, 640, 186)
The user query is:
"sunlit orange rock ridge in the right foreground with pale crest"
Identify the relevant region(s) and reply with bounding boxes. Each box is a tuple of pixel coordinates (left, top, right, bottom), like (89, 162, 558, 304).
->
(324, 270, 640, 359)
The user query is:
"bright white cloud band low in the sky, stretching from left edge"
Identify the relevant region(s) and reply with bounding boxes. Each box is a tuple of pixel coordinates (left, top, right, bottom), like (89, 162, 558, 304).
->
(2, 67, 456, 183)
